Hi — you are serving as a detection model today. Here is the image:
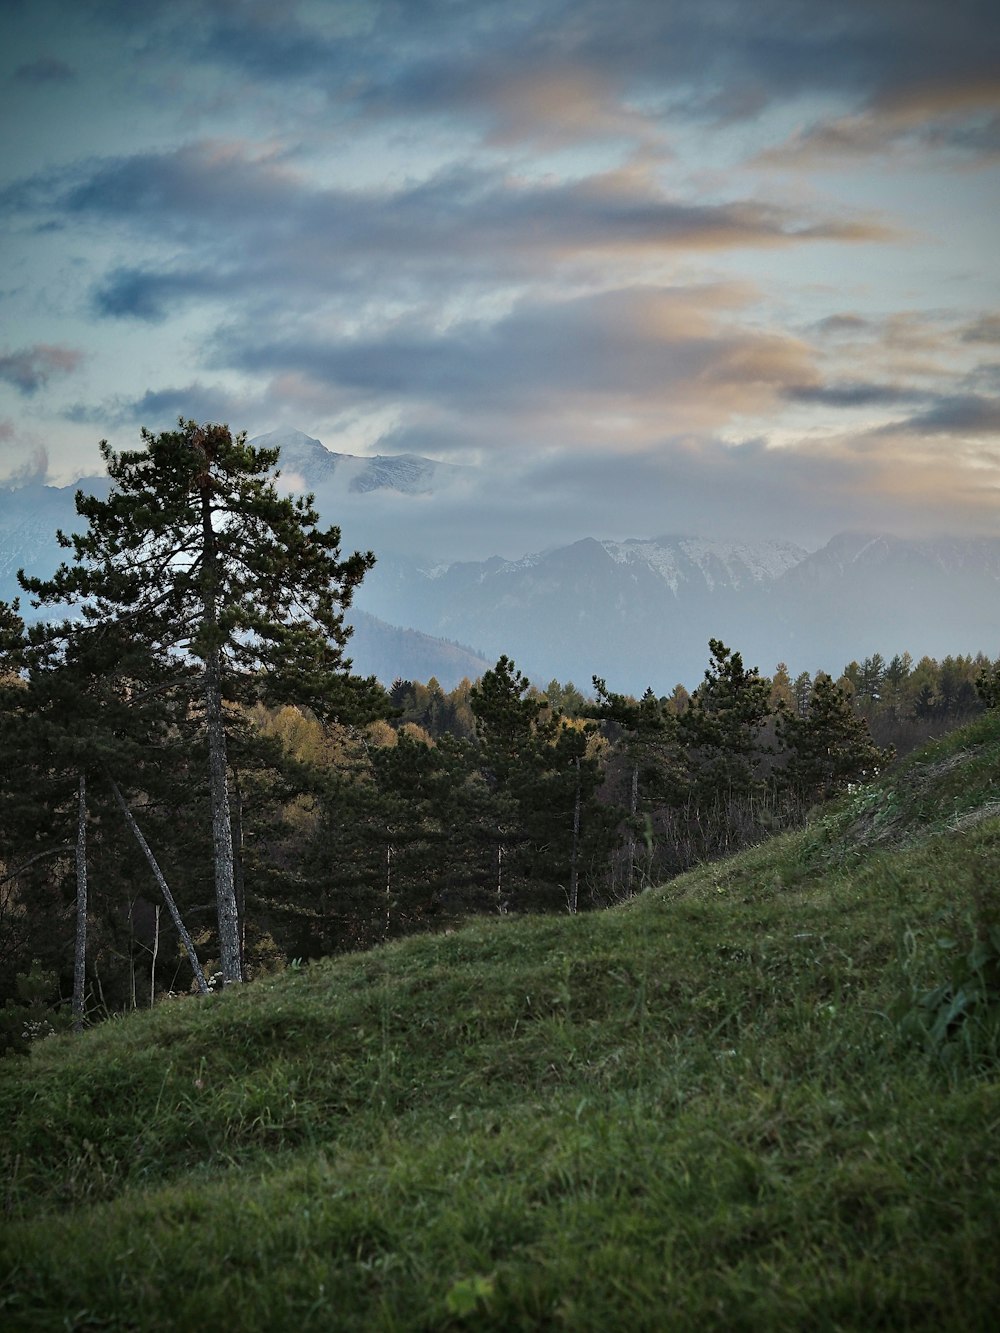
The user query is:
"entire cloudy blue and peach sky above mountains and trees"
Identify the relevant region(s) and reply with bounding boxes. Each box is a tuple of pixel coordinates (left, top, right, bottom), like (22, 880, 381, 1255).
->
(0, 0, 1000, 559)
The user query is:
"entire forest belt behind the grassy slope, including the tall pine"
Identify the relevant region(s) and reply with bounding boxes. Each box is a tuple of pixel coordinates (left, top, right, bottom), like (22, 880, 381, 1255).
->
(0, 421, 996, 1046)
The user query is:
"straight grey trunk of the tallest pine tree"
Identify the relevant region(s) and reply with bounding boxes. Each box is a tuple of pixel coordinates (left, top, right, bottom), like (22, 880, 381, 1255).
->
(201, 483, 243, 985)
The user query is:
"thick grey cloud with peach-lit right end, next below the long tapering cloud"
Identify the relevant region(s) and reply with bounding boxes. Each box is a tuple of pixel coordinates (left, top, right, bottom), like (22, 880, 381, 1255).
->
(216, 288, 809, 415)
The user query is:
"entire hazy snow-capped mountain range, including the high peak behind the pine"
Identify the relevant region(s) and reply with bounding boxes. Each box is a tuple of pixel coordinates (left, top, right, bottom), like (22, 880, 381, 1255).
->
(0, 432, 1000, 693)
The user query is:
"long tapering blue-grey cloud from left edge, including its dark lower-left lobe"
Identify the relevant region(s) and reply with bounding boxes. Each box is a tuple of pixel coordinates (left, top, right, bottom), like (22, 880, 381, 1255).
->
(5, 141, 893, 321)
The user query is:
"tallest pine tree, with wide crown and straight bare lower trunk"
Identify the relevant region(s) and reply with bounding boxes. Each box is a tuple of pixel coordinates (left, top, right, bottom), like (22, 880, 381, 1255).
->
(19, 421, 384, 982)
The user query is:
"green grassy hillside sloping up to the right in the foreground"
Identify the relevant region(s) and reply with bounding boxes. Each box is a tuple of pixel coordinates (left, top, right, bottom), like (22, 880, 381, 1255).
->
(0, 717, 1000, 1333)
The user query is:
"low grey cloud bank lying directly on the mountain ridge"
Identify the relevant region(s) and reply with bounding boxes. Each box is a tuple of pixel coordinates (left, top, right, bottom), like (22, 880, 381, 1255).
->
(317, 435, 999, 560)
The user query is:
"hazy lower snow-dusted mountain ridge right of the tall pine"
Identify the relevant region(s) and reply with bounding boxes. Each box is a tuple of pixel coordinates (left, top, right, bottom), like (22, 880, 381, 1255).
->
(360, 535, 1000, 693)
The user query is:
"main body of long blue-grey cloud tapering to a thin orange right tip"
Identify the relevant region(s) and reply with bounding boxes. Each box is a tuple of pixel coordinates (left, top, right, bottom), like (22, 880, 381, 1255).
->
(56, 143, 887, 251)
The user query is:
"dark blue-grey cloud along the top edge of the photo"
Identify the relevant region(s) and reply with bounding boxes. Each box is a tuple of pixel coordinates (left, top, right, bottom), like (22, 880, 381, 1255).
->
(56, 0, 1000, 136)
